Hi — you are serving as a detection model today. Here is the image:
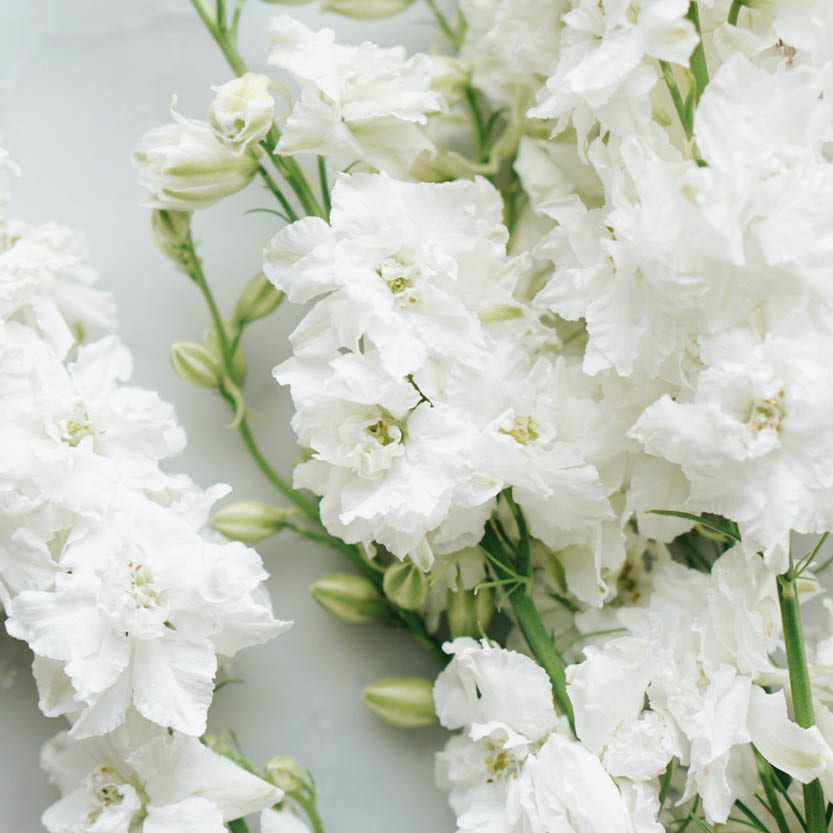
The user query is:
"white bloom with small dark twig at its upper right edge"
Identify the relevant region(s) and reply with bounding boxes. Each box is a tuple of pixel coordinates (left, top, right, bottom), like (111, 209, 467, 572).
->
(275, 351, 498, 569)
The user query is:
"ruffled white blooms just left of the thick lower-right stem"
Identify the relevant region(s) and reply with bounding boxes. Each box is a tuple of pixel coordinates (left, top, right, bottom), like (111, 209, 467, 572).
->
(567, 546, 830, 822)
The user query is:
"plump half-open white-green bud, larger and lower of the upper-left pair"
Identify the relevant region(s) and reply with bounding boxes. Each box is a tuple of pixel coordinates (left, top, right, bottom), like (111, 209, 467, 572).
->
(133, 104, 257, 211)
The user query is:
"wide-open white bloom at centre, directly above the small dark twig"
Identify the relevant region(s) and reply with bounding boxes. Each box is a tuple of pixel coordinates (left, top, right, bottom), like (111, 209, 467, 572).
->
(264, 174, 514, 376)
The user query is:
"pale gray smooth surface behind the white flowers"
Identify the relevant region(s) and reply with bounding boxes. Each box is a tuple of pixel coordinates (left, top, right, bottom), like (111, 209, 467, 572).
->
(0, 0, 454, 833)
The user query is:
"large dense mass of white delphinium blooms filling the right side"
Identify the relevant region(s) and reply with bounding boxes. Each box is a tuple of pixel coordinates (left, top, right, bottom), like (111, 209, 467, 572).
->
(120, 0, 833, 833)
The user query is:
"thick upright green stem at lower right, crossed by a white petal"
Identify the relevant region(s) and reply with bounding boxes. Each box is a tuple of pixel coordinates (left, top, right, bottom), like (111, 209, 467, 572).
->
(776, 565, 827, 833)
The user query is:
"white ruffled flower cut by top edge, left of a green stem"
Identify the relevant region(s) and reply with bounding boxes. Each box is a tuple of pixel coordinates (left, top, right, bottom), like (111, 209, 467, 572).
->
(529, 0, 699, 151)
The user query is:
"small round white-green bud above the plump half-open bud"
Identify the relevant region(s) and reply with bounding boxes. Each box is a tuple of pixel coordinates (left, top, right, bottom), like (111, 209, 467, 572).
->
(208, 72, 275, 156)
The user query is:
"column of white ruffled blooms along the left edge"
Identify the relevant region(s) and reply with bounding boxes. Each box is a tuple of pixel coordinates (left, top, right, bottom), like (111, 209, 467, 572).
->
(0, 156, 288, 833)
